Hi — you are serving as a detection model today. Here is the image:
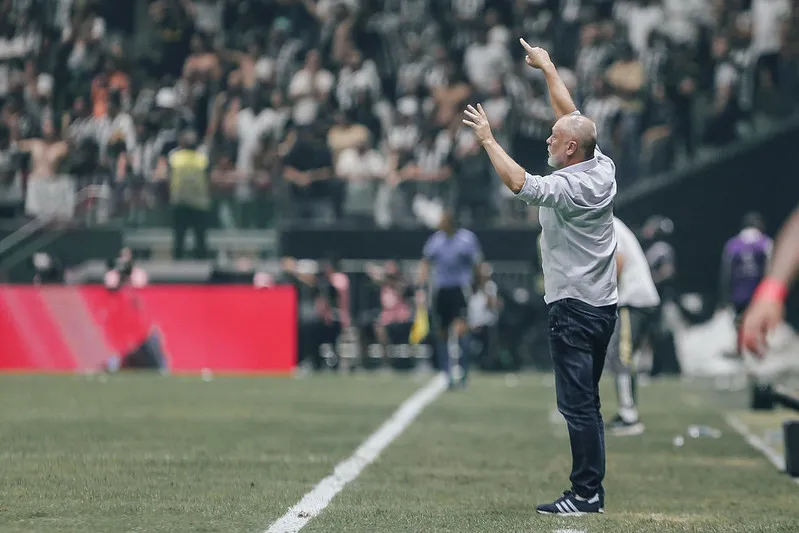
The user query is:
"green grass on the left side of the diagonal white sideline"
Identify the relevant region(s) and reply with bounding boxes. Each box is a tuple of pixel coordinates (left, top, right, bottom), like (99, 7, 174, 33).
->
(0, 376, 419, 533)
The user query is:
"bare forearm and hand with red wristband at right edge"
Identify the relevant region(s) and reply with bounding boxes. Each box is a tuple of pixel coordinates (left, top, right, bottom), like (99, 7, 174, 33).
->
(741, 208, 799, 357)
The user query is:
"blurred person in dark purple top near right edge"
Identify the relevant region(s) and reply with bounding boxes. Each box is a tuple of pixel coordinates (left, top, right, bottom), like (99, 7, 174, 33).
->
(721, 213, 774, 340)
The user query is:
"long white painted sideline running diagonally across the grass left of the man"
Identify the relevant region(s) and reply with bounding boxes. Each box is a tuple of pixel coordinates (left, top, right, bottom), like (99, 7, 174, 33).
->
(266, 375, 447, 533)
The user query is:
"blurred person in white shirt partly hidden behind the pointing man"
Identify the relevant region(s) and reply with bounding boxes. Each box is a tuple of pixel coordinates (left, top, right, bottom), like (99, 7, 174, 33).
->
(608, 218, 660, 436)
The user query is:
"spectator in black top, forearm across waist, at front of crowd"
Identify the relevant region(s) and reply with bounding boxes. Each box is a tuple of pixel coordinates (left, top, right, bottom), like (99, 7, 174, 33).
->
(283, 126, 344, 219)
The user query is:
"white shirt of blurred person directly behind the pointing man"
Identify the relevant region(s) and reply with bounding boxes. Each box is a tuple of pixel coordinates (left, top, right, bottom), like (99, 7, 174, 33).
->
(613, 218, 660, 308)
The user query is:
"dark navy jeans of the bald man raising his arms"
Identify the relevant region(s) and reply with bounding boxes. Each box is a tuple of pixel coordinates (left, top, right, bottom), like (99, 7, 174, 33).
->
(549, 298, 617, 498)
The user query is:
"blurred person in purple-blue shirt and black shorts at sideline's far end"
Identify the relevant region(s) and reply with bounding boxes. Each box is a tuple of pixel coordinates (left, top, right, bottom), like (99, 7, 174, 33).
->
(418, 211, 482, 388)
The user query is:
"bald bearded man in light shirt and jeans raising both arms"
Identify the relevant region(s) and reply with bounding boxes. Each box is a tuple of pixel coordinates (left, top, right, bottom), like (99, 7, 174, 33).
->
(463, 39, 619, 516)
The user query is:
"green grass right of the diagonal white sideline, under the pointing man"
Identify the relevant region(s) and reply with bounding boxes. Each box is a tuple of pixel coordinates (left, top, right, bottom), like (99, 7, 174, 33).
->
(304, 375, 799, 533)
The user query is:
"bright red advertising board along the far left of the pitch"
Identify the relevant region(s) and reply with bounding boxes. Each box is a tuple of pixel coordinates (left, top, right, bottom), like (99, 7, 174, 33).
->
(0, 285, 297, 373)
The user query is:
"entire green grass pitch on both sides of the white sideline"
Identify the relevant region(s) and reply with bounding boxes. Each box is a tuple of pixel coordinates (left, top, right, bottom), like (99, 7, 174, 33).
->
(0, 374, 799, 533)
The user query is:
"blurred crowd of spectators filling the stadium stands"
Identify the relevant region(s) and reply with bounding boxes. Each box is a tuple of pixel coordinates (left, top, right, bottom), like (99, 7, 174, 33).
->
(0, 0, 799, 228)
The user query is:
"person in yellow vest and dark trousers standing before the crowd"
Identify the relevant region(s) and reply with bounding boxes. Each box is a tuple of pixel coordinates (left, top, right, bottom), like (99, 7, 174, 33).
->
(168, 131, 211, 259)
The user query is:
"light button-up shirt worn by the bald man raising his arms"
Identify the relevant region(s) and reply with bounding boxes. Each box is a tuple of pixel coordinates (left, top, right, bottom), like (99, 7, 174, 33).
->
(516, 124, 619, 307)
